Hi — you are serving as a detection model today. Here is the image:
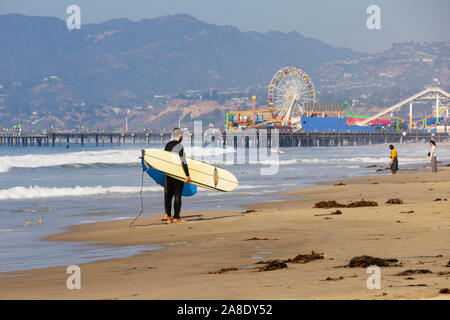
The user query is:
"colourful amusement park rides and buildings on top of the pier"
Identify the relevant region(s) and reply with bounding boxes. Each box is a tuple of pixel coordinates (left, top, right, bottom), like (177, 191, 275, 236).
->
(226, 67, 450, 132)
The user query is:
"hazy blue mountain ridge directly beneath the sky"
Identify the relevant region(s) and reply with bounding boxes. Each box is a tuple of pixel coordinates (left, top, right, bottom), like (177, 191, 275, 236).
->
(0, 14, 362, 104)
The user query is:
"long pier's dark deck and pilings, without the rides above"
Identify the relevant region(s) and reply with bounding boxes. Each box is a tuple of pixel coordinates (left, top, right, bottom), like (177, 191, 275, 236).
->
(0, 131, 450, 147)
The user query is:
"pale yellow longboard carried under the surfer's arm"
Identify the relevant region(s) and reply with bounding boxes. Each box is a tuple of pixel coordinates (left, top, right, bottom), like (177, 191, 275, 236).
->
(142, 149, 238, 192)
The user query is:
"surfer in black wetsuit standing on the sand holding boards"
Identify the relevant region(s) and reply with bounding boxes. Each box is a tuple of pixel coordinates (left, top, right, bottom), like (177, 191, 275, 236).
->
(162, 128, 191, 223)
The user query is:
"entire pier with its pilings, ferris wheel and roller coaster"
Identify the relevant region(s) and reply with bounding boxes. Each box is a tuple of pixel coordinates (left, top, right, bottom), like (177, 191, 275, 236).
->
(0, 67, 450, 148)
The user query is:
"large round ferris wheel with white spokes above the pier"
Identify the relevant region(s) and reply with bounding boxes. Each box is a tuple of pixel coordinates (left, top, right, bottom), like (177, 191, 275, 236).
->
(268, 67, 316, 121)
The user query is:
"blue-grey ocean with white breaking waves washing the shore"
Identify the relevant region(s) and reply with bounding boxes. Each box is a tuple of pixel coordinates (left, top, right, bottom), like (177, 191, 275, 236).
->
(0, 141, 450, 272)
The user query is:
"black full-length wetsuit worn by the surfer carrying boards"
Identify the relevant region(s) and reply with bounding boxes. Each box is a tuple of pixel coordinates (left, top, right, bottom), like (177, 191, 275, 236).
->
(164, 140, 189, 219)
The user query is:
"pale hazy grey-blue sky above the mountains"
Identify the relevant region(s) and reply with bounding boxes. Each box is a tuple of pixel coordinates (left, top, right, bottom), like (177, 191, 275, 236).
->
(0, 0, 450, 52)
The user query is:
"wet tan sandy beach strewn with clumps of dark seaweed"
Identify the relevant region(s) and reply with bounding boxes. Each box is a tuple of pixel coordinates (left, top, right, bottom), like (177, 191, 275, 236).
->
(0, 168, 450, 299)
